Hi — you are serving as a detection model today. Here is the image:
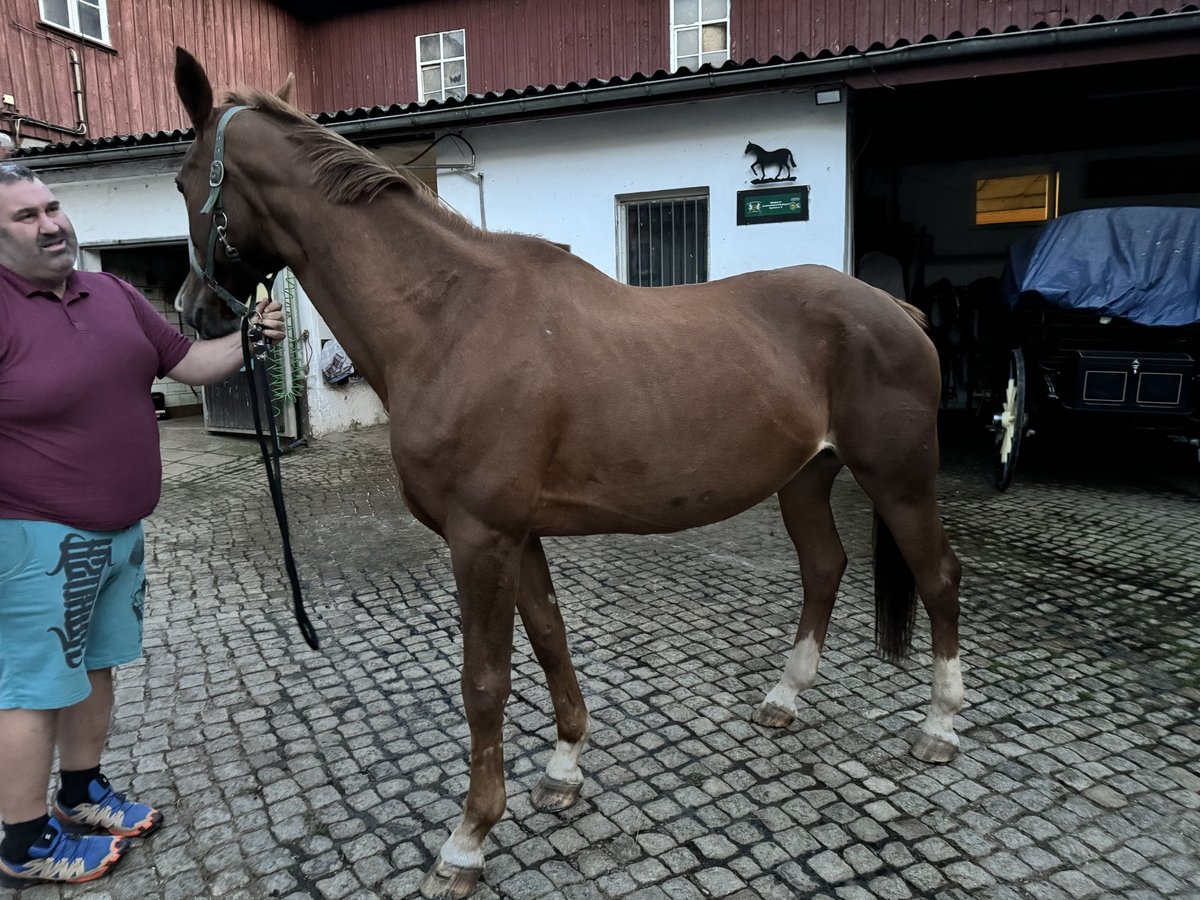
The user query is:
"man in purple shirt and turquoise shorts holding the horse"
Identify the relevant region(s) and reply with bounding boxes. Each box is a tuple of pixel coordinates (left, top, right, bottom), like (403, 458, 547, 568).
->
(0, 161, 283, 882)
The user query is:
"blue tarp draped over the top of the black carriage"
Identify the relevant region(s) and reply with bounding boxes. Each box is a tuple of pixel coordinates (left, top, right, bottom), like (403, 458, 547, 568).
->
(1004, 206, 1200, 325)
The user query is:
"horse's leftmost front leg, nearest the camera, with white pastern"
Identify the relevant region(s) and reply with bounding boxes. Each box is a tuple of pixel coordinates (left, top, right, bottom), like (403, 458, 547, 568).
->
(421, 522, 523, 900)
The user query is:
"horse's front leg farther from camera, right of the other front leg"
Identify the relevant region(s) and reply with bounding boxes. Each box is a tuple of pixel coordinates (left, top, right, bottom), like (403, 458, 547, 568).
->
(517, 538, 590, 810)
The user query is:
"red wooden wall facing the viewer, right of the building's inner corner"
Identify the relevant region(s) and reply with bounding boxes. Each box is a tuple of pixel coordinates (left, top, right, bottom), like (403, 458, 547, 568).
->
(301, 0, 1190, 112)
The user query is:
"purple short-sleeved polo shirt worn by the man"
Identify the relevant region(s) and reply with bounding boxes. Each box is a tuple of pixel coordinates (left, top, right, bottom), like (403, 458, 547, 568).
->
(0, 265, 191, 532)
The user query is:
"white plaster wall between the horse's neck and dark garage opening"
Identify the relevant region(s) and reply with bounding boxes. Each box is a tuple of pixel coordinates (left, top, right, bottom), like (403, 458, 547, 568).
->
(438, 91, 848, 278)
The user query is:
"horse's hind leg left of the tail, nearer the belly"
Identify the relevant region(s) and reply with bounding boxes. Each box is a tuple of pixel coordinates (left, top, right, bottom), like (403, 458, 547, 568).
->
(752, 451, 846, 727)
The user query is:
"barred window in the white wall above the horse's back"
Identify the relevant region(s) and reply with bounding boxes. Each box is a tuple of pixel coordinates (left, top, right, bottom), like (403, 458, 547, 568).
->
(617, 188, 708, 288)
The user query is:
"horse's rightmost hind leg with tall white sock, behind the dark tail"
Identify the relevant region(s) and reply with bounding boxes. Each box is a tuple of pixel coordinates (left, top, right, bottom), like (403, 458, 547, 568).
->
(850, 448, 962, 762)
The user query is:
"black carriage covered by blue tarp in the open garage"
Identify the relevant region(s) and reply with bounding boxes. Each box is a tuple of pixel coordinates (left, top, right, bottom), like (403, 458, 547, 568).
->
(991, 206, 1200, 491)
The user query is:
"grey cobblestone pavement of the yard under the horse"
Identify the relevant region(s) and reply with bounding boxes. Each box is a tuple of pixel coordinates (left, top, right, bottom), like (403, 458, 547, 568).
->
(0, 420, 1200, 900)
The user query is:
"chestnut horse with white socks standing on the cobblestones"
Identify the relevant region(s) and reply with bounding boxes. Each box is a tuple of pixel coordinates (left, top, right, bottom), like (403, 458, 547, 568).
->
(175, 49, 962, 898)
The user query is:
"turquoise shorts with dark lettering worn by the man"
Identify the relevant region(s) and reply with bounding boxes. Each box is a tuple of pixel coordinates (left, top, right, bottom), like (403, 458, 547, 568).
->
(0, 518, 145, 709)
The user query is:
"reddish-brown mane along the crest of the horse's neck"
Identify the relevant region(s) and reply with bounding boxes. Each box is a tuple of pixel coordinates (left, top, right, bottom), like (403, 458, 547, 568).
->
(224, 89, 475, 230)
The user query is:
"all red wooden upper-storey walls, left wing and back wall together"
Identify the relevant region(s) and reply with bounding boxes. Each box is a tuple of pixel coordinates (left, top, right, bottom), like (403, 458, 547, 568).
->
(0, 0, 1180, 146)
